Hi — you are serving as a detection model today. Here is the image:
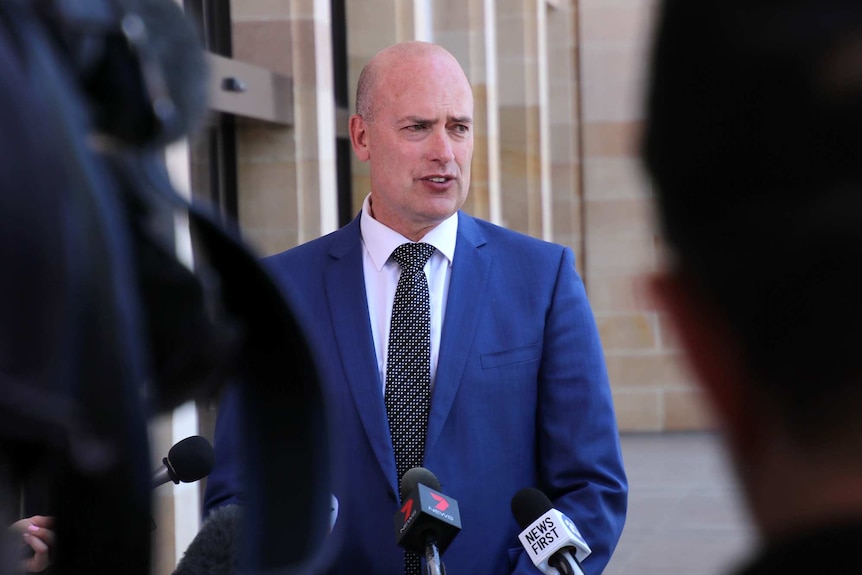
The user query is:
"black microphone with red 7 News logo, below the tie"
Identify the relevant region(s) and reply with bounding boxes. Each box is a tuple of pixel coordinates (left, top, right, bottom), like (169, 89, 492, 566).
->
(395, 467, 461, 575)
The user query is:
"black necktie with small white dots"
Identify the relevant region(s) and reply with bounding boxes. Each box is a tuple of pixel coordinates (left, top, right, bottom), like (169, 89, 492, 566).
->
(385, 243, 435, 575)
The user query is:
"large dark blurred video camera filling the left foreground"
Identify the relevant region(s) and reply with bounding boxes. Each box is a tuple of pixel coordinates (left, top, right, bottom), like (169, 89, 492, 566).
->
(0, 0, 330, 575)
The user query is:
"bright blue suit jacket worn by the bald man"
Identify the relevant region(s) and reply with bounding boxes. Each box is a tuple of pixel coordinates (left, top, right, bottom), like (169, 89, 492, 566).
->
(205, 213, 627, 575)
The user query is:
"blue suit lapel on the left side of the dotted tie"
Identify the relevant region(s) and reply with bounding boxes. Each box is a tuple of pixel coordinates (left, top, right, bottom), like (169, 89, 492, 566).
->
(324, 218, 398, 493)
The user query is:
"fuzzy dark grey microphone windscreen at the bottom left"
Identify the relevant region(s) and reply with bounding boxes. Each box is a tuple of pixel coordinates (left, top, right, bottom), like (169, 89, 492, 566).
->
(172, 505, 243, 575)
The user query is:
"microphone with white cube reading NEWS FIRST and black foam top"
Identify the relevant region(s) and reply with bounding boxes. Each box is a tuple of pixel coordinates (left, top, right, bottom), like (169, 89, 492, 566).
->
(512, 487, 592, 575)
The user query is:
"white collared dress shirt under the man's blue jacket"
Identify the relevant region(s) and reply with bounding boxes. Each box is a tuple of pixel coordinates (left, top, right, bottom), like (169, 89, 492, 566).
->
(359, 196, 458, 393)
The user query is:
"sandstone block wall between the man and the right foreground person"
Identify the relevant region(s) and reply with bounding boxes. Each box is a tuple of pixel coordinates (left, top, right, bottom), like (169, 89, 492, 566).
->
(579, 0, 711, 431)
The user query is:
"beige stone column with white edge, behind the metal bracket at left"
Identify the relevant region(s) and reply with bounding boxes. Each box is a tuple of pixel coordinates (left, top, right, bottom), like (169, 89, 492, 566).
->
(231, 0, 337, 254)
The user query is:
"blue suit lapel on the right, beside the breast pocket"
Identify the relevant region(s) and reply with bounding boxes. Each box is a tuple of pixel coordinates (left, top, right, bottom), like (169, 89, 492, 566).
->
(425, 212, 491, 453)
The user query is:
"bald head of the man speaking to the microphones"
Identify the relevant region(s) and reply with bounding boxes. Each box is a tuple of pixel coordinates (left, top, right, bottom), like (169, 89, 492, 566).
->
(350, 38, 473, 241)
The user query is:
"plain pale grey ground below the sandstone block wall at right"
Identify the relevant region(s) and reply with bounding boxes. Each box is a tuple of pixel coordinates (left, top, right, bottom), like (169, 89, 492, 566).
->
(604, 433, 755, 575)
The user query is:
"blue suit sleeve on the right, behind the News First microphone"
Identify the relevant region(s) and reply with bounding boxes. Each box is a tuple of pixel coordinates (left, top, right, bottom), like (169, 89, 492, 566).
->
(514, 248, 628, 575)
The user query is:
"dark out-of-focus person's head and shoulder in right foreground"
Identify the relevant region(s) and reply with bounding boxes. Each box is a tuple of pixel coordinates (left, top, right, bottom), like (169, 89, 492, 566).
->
(642, 0, 862, 575)
